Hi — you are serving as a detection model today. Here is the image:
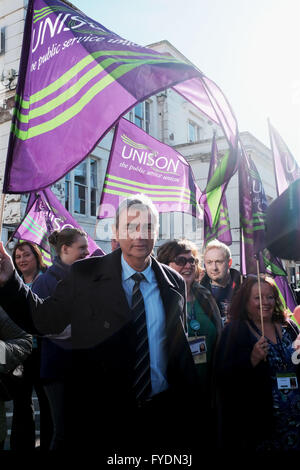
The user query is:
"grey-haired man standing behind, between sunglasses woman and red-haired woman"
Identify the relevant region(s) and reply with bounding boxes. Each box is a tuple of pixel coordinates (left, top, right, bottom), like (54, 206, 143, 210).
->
(201, 240, 240, 323)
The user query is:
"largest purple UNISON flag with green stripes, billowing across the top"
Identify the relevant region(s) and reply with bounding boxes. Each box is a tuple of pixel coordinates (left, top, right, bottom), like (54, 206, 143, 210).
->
(3, 0, 237, 193)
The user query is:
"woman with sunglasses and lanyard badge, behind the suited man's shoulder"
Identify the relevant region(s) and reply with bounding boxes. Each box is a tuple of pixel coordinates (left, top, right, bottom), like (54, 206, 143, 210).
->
(157, 240, 222, 438)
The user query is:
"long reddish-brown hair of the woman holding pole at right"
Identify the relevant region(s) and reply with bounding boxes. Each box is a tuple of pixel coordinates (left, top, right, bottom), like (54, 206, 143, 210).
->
(229, 274, 287, 323)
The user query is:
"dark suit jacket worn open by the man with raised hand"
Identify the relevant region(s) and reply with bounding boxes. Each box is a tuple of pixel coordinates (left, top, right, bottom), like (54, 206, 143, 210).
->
(0, 249, 196, 450)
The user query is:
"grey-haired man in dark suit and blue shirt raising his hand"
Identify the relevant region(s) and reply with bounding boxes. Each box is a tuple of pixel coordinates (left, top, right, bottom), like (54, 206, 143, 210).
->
(0, 195, 200, 451)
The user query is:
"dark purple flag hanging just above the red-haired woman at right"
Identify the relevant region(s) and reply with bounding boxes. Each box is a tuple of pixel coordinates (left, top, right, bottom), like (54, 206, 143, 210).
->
(239, 145, 294, 309)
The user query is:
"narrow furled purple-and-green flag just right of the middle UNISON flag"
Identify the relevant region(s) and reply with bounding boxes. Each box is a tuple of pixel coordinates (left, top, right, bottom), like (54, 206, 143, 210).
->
(202, 130, 232, 245)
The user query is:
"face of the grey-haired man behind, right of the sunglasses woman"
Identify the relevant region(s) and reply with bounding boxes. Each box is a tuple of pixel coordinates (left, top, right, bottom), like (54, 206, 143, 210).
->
(204, 248, 232, 285)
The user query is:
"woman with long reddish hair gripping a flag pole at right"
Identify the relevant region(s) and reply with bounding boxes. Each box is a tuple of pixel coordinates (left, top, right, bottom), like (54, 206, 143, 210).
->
(216, 269, 300, 451)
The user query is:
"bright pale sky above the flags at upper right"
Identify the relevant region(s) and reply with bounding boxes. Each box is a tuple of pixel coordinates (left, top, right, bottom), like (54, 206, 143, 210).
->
(72, 0, 300, 163)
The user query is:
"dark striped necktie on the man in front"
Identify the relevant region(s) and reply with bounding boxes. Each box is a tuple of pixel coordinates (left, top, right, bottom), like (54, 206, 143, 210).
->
(131, 273, 151, 400)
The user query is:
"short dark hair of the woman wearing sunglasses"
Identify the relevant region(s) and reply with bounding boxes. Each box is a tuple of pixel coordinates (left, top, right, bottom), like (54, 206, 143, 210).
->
(156, 239, 202, 278)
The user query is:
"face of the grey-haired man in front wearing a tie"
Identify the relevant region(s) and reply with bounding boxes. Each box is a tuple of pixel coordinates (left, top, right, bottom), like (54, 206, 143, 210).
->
(116, 205, 157, 268)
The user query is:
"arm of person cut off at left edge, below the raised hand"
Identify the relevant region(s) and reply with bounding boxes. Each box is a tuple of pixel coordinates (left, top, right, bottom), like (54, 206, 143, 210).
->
(0, 310, 32, 372)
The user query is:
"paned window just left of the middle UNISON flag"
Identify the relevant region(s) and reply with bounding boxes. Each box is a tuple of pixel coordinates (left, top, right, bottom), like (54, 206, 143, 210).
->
(65, 157, 99, 217)
